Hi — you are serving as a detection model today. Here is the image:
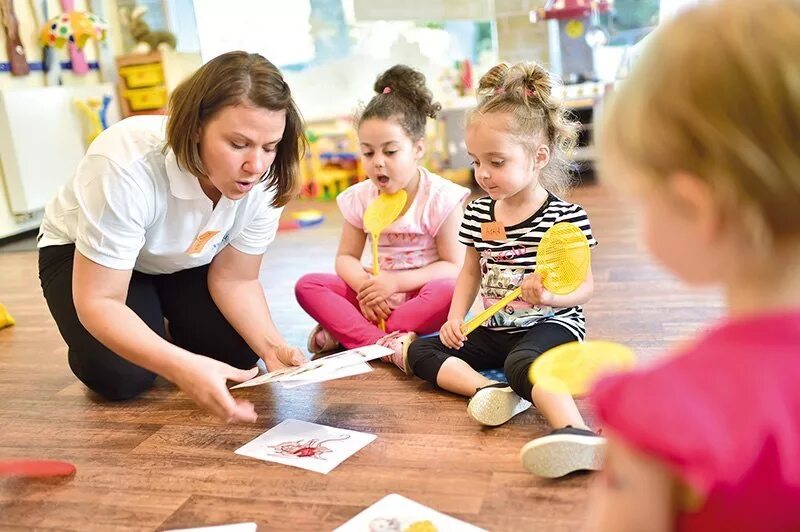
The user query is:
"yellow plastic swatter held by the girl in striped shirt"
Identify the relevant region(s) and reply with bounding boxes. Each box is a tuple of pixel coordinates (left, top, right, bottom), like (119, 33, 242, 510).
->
(461, 222, 591, 334)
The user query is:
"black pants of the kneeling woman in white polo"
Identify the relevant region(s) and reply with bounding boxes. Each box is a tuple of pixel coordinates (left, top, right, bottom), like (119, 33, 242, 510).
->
(39, 244, 258, 400)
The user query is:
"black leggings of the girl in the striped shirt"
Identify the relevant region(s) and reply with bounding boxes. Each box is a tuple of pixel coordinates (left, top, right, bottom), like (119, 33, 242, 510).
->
(408, 322, 577, 401)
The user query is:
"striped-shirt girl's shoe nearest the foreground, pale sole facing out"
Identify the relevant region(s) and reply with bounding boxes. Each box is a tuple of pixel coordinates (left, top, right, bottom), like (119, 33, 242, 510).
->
(520, 425, 606, 478)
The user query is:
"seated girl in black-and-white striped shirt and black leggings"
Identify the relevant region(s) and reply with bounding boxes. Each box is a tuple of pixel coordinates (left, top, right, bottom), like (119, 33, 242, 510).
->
(407, 63, 603, 477)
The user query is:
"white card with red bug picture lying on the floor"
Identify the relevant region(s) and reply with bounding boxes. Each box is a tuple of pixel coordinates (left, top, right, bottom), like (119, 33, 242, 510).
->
(235, 419, 376, 474)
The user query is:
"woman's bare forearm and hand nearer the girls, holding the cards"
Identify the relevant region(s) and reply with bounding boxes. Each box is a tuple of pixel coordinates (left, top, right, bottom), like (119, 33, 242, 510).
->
(208, 245, 305, 371)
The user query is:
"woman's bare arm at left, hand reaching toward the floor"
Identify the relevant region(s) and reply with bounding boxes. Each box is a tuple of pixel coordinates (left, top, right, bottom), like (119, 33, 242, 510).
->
(72, 250, 257, 422)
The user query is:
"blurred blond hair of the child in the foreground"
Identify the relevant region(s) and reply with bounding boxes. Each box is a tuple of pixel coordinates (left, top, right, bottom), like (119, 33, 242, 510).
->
(601, 0, 800, 252)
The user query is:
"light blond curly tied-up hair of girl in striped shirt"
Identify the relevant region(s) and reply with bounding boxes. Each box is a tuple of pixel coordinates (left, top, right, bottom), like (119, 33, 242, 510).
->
(467, 63, 578, 194)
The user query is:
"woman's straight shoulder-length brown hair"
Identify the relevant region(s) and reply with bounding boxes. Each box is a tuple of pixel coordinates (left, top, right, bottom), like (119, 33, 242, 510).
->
(167, 52, 306, 207)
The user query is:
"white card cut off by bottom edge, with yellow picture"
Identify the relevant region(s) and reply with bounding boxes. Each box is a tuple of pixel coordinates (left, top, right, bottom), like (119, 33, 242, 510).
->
(334, 493, 486, 532)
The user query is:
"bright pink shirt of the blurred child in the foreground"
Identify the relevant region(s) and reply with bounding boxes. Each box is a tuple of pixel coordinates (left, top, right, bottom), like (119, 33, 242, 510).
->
(593, 310, 800, 531)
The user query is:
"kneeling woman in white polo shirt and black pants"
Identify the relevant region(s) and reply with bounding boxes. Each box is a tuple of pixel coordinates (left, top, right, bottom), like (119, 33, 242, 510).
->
(39, 52, 305, 421)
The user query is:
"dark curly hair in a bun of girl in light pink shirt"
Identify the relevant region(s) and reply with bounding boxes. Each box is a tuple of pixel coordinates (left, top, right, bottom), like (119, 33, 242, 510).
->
(356, 65, 442, 141)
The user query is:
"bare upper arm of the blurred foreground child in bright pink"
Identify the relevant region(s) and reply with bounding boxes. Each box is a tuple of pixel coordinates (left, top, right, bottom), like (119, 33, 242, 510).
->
(586, 437, 675, 532)
